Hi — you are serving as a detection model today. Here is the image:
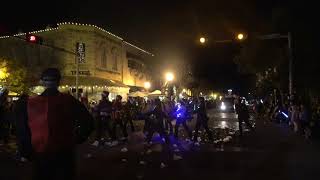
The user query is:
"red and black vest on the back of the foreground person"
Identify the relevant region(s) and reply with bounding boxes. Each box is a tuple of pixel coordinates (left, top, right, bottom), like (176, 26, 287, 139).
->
(28, 94, 75, 153)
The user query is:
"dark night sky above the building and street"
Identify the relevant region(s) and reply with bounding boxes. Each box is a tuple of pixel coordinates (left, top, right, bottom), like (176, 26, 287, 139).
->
(0, 0, 292, 91)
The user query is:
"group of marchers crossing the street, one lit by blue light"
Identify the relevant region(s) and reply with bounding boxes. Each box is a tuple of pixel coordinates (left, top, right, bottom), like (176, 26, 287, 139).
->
(90, 91, 212, 146)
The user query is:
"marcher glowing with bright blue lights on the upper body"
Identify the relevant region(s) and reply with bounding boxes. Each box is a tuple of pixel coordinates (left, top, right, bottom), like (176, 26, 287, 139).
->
(174, 101, 192, 140)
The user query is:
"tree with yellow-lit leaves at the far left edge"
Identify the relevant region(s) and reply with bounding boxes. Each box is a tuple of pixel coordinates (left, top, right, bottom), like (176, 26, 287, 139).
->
(0, 57, 31, 94)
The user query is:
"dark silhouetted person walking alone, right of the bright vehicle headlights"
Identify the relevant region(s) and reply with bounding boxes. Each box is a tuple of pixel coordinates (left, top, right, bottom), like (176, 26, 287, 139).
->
(235, 98, 253, 136)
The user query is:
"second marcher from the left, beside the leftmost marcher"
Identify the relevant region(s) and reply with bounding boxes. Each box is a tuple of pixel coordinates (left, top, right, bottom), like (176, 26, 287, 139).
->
(111, 95, 128, 143)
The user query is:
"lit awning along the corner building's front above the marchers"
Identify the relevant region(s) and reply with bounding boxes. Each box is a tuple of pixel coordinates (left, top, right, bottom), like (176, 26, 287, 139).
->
(60, 76, 129, 88)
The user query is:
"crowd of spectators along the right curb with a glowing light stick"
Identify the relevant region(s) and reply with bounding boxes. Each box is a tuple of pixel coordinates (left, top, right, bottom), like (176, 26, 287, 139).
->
(255, 94, 320, 139)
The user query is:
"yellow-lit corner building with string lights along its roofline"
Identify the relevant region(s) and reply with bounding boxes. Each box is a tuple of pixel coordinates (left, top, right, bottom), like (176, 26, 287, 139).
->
(0, 22, 153, 99)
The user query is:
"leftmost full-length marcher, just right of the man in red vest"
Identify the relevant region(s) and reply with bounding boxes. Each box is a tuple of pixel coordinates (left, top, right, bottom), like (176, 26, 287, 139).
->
(92, 91, 112, 146)
